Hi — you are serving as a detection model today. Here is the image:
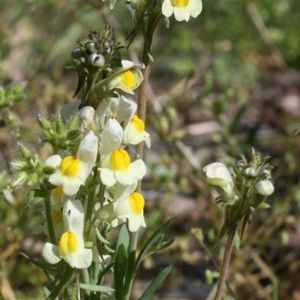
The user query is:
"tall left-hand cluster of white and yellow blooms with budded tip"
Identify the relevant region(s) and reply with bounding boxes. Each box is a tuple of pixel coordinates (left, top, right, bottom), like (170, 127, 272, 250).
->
(43, 31, 150, 269)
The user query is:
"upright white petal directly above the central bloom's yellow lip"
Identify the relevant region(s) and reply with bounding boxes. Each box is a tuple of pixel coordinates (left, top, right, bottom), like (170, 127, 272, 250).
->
(101, 119, 123, 155)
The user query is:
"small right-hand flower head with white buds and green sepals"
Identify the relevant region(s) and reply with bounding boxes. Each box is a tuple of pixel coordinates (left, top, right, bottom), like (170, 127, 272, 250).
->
(203, 150, 274, 236)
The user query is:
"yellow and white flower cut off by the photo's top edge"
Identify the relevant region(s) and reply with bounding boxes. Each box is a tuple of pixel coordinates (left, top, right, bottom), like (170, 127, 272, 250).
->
(162, 0, 202, 22)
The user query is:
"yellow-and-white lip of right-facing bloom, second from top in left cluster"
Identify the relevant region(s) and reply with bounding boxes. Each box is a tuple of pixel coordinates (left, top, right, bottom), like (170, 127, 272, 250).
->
(123, 114, 150, 146)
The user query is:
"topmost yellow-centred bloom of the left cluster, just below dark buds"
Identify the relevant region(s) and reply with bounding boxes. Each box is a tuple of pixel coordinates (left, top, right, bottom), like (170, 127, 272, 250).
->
(109, 60, 143, 94)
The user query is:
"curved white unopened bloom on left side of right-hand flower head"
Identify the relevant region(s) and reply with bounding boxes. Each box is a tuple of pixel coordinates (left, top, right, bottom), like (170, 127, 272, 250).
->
(203, 162, 233, 197)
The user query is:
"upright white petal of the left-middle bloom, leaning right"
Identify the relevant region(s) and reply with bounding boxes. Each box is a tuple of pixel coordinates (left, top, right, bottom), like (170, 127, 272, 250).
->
(77, 131, 98, 168)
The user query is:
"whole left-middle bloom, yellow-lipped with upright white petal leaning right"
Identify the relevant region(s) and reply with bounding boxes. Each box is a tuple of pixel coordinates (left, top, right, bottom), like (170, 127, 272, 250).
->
(45, 131, 98, 196)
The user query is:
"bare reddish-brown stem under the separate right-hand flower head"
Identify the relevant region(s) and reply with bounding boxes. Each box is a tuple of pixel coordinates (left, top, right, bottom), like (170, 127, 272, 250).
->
(215, 230, 236, 300)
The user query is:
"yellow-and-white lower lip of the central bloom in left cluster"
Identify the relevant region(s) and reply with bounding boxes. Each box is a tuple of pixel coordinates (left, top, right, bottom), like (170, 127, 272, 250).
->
(100, 148, 146, 186)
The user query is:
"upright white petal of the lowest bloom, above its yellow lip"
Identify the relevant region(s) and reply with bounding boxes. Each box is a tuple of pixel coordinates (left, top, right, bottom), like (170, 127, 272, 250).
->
(63, 200, 84, 240)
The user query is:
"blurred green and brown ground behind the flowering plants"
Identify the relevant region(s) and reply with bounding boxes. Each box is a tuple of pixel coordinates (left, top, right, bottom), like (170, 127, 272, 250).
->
(0, 0, 300, 300)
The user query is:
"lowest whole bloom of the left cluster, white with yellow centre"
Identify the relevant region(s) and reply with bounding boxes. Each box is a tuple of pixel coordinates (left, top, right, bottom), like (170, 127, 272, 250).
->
(42, 200, 93, 269)
